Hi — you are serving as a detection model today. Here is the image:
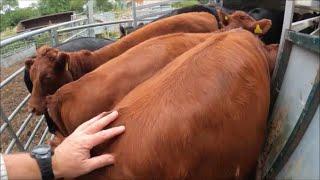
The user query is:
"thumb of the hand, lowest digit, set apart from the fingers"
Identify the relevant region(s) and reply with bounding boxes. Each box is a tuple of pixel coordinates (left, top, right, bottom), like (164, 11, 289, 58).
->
(86, 154, 114, 172)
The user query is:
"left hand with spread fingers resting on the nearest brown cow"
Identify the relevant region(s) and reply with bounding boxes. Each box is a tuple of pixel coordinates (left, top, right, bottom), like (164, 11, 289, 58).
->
(52, 111, 125, 178)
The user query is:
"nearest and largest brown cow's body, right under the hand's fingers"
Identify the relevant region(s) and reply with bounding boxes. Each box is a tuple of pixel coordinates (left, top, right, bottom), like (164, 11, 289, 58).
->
(77, 29, 275, 179)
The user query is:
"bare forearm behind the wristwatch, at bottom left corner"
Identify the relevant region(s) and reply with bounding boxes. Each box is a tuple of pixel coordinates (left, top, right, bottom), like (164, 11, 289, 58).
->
(3, 153, 41, 180)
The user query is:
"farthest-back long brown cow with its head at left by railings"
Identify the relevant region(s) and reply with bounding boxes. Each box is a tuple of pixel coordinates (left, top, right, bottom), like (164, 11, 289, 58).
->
(25, 13, 218, 114)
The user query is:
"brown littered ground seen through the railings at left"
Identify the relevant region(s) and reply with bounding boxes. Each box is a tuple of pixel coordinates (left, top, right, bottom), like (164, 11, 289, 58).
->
(0, 61, 50, 153)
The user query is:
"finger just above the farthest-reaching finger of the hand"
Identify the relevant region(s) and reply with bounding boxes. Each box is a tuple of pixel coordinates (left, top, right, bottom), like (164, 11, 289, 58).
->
(85, 111, 118, 134)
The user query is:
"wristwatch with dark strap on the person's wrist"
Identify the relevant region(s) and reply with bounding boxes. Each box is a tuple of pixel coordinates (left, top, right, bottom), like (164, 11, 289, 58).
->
(30, 144, 54, 180)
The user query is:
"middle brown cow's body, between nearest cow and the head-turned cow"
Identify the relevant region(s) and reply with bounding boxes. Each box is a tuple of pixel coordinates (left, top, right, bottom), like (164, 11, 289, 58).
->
(47, 13, 271, 145)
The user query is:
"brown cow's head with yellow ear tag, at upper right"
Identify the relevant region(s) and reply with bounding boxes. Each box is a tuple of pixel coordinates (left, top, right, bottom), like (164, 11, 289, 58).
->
(220, 11, 272, 36)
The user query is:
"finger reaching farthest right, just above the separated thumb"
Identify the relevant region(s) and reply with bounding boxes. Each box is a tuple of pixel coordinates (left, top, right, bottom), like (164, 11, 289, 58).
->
(89, 126, 125, 148)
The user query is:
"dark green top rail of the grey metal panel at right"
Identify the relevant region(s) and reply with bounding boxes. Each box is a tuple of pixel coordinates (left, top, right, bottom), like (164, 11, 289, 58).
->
(287, 31, 320, 53)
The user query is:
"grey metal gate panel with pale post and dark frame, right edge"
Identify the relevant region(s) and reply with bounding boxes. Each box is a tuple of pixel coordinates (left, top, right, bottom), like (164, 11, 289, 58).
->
(252, 0, 320, 179)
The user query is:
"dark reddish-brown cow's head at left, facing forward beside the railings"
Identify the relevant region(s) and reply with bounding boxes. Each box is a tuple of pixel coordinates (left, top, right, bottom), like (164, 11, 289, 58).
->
(25, 46, 72, 115)
